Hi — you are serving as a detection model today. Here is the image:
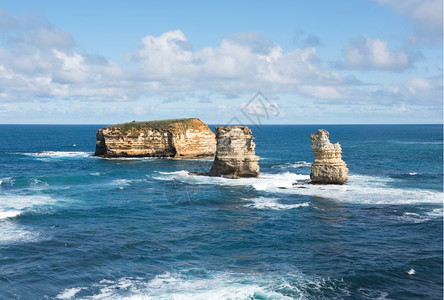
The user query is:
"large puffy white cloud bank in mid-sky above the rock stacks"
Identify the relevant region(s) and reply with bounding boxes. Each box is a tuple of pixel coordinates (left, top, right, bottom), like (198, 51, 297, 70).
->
(124, 30, 354, 93)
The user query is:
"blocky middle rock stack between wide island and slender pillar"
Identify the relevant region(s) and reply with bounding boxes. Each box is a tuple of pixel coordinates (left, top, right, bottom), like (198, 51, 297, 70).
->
(207, 126, 259, 178)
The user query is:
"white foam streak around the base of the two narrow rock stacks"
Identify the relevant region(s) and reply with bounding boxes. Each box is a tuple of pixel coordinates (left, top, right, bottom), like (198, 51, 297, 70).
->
(154, 170, 443, 204)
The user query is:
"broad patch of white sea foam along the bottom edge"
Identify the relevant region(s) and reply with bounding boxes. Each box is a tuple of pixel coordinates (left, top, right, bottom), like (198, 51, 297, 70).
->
(57, 271, 348, 300)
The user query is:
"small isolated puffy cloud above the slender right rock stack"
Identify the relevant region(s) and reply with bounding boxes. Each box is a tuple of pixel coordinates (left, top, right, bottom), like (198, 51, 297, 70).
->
(338, 37, 411, 71)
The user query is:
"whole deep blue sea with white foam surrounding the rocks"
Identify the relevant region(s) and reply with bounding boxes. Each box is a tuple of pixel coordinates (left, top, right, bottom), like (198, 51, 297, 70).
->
(0, 125, 443, 299)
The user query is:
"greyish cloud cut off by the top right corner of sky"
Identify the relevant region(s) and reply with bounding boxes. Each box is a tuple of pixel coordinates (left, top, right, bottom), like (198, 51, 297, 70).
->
(377, 0, 443, 46)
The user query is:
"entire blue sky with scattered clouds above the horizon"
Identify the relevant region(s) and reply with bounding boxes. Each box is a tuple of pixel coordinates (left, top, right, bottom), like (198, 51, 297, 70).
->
(0, 0, 443, 125)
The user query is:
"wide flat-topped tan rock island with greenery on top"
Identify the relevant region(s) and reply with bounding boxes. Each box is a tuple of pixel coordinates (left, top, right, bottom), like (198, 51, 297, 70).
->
(94, 118, 216, 158)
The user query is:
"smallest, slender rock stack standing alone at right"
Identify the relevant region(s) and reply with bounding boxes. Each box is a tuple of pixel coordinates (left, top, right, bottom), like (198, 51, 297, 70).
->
(310, 129, 348, 184)
